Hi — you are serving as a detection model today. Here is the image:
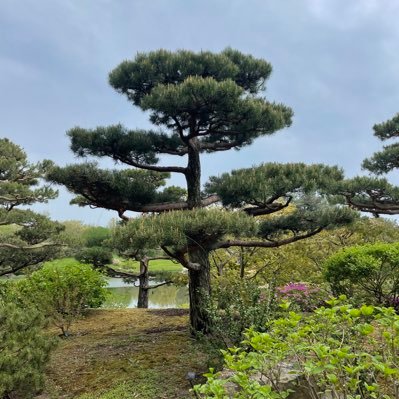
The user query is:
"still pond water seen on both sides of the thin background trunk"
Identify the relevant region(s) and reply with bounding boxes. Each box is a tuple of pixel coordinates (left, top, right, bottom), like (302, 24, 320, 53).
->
(103, 278, 188, 309)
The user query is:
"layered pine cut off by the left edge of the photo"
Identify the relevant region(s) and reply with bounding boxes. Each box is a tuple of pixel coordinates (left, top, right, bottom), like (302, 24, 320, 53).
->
(0, 139, 63, 276)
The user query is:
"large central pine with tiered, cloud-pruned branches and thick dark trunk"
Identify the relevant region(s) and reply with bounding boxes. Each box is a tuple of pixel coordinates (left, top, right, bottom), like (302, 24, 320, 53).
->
(49, 49, 351, 332)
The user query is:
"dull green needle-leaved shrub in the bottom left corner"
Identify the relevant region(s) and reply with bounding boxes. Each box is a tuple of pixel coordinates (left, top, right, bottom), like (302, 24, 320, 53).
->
(0, 302, 55, 398)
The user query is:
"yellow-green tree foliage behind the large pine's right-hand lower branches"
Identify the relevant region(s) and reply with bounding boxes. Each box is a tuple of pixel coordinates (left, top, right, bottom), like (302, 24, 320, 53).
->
(213, 217, 399, 286)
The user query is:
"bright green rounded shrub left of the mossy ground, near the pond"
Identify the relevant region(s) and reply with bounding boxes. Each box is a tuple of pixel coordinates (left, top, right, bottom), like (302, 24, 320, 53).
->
(13, 263, 107, 336)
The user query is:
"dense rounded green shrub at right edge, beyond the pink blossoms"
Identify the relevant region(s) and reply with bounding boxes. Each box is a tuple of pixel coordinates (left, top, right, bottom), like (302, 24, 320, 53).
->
(325, 243, 399, 306)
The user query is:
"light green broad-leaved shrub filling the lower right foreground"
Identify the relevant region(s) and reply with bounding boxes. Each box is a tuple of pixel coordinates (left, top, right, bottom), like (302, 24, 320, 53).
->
(195, 299, 399, 399)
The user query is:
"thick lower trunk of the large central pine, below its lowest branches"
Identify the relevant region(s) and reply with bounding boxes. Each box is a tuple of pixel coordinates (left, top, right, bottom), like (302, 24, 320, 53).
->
(188, 247, 211, 334)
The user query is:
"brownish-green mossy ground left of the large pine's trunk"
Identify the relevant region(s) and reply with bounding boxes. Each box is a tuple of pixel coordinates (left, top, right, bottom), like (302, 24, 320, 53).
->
(40, 309, 207, 399)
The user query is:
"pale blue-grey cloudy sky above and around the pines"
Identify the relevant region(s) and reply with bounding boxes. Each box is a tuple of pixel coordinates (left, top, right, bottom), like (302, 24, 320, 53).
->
(0, 0, 399, 225)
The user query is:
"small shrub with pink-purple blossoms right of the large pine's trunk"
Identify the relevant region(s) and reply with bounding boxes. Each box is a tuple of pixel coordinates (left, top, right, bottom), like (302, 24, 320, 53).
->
(277, 282, 325, 312)
